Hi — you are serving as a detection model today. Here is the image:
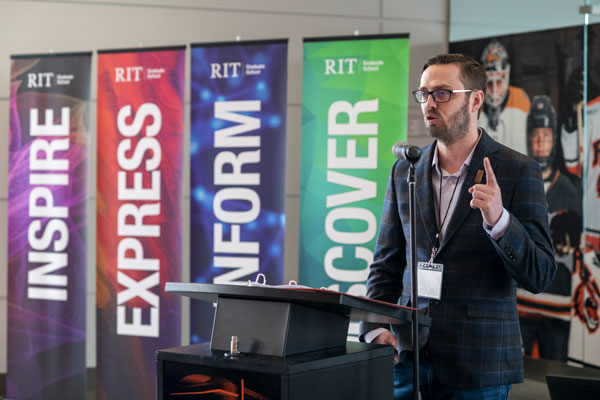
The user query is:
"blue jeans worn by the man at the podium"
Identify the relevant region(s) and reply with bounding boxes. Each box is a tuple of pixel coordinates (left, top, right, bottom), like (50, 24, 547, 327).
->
(394, 351, 512, 400)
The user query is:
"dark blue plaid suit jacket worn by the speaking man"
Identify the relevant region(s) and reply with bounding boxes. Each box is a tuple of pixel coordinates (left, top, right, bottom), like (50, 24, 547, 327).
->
(361, 131, 556, 388)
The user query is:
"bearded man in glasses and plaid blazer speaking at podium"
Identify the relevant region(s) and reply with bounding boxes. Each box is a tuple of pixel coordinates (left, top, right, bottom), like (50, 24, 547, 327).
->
(361, 54, 556, 399)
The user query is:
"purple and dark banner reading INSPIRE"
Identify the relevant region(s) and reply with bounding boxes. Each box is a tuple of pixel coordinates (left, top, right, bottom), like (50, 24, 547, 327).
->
(6, 53, 91, 399)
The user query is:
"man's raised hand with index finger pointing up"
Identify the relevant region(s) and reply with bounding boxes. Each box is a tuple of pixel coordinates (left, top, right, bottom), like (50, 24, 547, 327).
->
(469, 157, 502, 227)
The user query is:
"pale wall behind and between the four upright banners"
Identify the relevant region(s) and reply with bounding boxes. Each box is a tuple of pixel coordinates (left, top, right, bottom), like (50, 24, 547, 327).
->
(0, 0, 448, 373)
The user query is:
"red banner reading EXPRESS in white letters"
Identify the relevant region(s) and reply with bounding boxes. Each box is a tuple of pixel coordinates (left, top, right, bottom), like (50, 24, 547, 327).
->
(96, 47, 185, 399)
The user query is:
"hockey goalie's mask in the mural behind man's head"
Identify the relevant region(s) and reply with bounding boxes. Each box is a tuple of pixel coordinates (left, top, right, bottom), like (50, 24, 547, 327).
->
(481, 40, 510, 108)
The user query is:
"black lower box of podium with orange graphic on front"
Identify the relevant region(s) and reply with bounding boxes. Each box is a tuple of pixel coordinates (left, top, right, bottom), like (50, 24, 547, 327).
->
(156, 342, 393, 400)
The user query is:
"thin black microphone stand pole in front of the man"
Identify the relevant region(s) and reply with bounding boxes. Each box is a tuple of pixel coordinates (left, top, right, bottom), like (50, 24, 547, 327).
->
(406, 154, 421, 400)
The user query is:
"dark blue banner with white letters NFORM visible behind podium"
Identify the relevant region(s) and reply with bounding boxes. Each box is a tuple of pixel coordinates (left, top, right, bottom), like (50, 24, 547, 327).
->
(190, 39, 287, 343)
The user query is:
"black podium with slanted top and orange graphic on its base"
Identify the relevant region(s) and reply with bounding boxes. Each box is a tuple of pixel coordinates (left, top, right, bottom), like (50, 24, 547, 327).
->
(157, 283, 431, 399)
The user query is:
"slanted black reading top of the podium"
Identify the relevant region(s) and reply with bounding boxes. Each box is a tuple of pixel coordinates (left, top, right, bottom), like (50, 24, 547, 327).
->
(165, 282, 431, 326)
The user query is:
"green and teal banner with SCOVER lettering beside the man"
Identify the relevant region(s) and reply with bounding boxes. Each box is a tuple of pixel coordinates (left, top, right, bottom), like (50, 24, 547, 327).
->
(299, 34, 409, 334)
